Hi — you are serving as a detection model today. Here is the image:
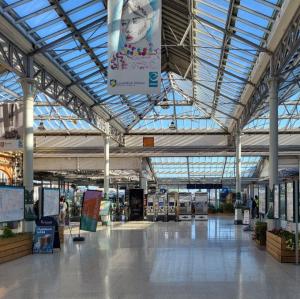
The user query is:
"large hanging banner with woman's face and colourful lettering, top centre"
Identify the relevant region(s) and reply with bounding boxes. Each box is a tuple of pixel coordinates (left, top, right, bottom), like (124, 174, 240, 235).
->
(107, 0, 161, 95)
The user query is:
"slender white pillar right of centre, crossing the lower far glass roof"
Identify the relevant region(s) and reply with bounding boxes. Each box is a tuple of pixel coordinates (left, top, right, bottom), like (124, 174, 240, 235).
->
(234, 121, 243, 224)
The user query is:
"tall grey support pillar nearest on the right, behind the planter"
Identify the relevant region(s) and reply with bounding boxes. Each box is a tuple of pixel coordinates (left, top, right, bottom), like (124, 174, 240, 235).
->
(267, 58, 278, 218)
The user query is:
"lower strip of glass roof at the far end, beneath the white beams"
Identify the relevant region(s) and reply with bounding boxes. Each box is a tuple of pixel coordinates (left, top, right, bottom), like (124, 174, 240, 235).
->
(151, 156, 261, 180)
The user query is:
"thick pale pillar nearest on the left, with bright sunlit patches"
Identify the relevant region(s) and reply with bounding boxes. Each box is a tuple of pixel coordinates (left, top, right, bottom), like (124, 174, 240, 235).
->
(21, 78, 35, 232)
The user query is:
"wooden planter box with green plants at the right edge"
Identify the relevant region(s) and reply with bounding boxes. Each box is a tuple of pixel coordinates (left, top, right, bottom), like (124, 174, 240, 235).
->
(267, 232, 300, 263)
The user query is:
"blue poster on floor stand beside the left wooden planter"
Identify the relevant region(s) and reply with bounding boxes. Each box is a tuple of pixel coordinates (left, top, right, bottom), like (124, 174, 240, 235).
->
(33, 226, 54, 253)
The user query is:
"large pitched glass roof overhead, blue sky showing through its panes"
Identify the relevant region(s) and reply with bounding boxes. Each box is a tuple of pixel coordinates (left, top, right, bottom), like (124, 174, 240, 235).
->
(0, 0, 283, 131)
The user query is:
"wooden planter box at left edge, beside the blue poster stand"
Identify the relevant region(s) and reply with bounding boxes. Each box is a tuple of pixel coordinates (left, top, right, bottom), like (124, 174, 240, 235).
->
(0, 233, 32, 264)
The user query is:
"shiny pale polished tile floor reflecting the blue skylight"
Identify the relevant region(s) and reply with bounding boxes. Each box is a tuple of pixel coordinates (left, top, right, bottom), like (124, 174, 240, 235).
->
(0, 217, 300, 299)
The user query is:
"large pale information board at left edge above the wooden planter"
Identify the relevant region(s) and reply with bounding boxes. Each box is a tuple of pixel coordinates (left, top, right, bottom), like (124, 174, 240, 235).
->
(0, 186, 24, 222)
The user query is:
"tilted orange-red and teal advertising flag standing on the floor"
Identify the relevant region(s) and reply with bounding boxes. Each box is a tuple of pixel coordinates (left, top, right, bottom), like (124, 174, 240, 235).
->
(80, 190, 102, 232)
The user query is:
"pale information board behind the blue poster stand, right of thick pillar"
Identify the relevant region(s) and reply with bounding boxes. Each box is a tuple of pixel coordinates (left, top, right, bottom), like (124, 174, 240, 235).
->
(42, 188, 59, 216)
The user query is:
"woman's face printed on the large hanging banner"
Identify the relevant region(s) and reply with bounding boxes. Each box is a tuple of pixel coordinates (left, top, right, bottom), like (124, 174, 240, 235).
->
(121, 5, 151, 44)
